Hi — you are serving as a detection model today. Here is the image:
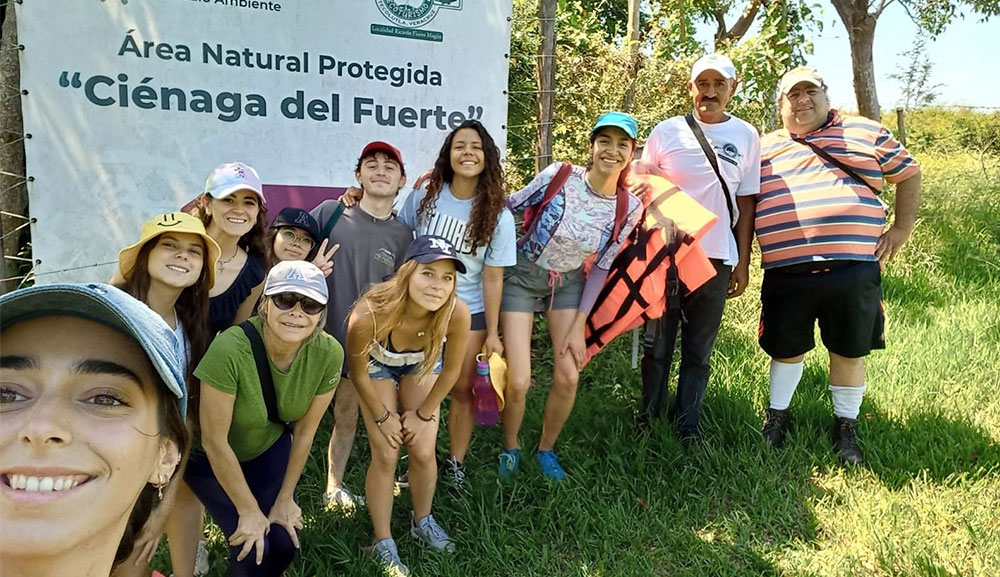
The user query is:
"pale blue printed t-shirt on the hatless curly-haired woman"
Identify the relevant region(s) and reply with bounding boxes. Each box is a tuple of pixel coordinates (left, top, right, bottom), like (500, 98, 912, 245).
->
(396, 183, 517, 314)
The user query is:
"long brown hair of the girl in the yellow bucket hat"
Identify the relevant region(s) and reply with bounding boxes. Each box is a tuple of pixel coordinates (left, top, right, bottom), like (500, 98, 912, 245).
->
(116, 235, 211, 424)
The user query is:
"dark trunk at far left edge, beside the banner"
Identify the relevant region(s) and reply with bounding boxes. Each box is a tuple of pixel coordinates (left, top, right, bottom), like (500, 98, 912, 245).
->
(0, 8, 29, 294)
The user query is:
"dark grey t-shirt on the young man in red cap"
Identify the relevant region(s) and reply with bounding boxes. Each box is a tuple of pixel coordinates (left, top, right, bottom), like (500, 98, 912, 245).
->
(310, 200, 413, 356)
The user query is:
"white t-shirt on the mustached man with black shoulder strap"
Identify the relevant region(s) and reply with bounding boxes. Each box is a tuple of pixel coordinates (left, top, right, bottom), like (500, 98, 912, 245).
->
(642, 116, 760, 265)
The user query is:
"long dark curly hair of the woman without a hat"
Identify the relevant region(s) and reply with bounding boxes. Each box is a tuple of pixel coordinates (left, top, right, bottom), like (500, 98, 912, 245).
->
(417, 120, 507, 252)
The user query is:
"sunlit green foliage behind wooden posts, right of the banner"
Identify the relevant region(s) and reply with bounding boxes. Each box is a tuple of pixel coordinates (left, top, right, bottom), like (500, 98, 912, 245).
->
(507, 0, 821, 184)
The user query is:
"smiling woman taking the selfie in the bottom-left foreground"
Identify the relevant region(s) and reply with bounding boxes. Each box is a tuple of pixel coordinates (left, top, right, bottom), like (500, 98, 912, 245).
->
(0, 284, 189, 577)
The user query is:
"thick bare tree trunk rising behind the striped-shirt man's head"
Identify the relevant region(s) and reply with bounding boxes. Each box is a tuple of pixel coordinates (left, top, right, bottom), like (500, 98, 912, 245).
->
(832, 0, 882, 120)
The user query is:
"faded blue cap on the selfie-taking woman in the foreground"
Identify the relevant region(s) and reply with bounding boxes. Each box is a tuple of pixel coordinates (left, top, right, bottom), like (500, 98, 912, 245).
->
(0, 283, 187, 416)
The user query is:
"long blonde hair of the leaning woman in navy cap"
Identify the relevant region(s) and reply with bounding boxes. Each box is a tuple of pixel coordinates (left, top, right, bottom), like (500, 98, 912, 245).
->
(350, 260, 458, 379)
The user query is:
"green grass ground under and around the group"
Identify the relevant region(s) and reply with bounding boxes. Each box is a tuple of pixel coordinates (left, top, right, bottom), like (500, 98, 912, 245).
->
(152, 156, 1000, 577)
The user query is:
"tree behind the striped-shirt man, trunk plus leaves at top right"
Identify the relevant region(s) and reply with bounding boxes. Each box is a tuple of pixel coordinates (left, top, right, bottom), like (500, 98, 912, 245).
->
(830, 0, 1000, 120)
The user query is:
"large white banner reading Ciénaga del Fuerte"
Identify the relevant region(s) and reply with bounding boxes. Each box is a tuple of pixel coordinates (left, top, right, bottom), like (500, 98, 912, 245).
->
(16, 0, 511, 283)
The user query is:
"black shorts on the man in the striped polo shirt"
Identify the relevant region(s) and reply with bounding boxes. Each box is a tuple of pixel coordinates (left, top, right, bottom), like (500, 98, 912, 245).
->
(757, 261, 885, 359)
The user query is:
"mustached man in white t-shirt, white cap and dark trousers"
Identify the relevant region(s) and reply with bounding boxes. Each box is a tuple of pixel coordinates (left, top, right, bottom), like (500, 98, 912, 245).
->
(639, 54, 760, 445)
